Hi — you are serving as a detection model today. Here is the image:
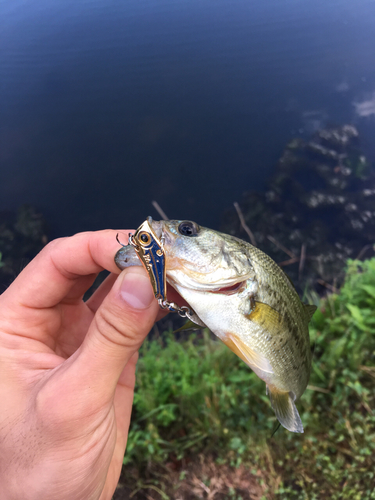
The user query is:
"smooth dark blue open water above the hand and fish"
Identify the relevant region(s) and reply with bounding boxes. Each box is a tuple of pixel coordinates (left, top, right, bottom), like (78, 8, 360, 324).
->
(0, 0, 375, 236)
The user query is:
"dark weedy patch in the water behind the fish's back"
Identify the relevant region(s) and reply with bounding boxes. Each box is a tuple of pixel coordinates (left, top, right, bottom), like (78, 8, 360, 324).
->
(221, 125, 375, 295)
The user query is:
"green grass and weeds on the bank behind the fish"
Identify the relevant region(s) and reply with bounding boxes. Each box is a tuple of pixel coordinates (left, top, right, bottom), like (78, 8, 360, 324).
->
(124, 259, 375, 500)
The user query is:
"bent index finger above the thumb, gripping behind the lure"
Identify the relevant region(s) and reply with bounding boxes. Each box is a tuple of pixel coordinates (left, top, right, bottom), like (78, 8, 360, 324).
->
(1, 229, 129, 309)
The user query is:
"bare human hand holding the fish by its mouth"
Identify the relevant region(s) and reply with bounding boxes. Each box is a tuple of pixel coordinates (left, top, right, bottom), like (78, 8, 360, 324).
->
(0, 230, 172, 500)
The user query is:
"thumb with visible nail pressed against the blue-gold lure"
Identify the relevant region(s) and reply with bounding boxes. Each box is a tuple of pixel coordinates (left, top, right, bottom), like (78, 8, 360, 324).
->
(71, 267, 159, 399)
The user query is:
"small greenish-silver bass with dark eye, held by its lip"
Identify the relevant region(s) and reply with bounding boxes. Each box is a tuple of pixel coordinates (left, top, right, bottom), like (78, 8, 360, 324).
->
(115, 217, 316, 433)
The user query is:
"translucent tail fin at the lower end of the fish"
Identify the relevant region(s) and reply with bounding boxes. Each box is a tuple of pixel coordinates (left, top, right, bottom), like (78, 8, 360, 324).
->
(267, 385, 303, 432)
